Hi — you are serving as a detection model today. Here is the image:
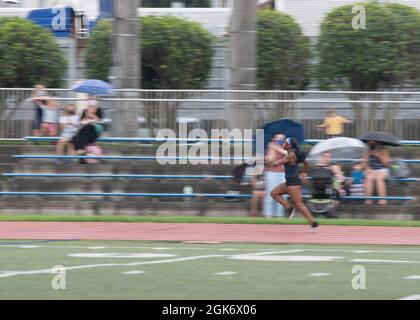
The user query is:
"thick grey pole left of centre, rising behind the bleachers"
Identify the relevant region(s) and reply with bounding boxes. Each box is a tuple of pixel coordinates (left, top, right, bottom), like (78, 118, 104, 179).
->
(111, 0, 141, 137)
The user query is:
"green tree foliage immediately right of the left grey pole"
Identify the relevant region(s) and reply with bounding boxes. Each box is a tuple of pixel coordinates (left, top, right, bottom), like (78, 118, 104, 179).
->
(141, 16, 213, 89)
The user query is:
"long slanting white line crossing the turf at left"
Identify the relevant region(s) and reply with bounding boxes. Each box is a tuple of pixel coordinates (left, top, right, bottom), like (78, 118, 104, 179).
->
(0, 255, 225, 278)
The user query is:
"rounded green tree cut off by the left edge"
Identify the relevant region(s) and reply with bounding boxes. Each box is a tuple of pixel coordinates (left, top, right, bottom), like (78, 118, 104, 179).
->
(0, 18, 67, 88)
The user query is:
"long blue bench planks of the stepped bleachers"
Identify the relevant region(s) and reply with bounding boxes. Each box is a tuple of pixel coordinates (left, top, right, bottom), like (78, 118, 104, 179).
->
(0, 137, 420, 214)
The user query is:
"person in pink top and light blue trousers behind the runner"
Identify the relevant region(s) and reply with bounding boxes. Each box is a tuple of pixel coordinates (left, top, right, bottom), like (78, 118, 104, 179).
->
(264, 134, 287, 218)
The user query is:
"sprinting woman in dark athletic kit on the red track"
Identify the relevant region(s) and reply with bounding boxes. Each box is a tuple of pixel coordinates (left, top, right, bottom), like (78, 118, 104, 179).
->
(271, 138, 319, 231)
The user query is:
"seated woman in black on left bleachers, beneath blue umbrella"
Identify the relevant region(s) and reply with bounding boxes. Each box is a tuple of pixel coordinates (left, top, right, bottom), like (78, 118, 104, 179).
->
(72, 100, 103, 163)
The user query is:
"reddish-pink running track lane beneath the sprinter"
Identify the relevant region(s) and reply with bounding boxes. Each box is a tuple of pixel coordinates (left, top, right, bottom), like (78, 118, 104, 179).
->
(0, 222, 420, 245)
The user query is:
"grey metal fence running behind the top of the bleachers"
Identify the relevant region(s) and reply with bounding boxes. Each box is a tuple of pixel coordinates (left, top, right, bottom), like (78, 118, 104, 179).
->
(0, 89, 420, 140)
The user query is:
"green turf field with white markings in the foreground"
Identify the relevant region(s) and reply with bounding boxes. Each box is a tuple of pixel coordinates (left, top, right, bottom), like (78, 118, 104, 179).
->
(0, 241, 420, 300)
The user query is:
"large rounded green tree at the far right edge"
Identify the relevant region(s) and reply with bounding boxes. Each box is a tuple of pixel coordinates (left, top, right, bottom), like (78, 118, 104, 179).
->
(317, 2, 420, 91)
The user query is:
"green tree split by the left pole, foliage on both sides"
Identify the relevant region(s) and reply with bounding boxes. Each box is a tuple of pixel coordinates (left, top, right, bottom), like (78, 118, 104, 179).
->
(86, 16, 213, 89)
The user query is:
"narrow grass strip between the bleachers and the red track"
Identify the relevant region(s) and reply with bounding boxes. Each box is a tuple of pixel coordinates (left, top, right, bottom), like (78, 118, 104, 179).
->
(0, 215, 420, 227)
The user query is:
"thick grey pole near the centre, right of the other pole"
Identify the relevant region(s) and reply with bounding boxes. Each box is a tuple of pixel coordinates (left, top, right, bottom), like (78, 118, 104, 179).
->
(230, 0, 257, 130)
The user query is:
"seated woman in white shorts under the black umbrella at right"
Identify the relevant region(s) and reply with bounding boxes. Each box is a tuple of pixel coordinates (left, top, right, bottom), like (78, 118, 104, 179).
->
(363, 141, 390, 205)
